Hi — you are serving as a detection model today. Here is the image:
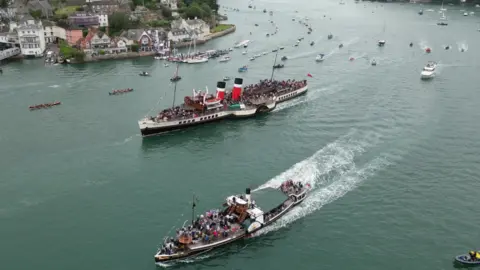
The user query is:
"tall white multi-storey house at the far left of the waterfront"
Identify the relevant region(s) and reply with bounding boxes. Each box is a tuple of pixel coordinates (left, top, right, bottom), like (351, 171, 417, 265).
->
(15, 15, 46, 57)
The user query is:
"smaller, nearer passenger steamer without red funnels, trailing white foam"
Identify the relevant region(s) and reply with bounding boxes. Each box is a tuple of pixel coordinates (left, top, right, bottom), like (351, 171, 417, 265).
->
(154, 180, 311, 263)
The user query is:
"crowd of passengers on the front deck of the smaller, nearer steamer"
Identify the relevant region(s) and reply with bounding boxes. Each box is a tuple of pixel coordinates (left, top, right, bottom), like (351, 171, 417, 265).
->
(160, 210, 239, 255)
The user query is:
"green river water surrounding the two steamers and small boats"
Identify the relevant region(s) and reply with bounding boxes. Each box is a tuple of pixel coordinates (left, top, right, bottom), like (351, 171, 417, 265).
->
(0, 0, 480, 270)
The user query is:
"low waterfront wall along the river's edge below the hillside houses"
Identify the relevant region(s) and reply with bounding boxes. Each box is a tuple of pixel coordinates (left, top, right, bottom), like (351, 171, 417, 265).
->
(75, 24, 237, 64)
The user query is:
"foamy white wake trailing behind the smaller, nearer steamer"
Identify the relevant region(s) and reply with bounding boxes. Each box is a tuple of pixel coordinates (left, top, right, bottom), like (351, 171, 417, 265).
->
(254, 130, 390, 236)
